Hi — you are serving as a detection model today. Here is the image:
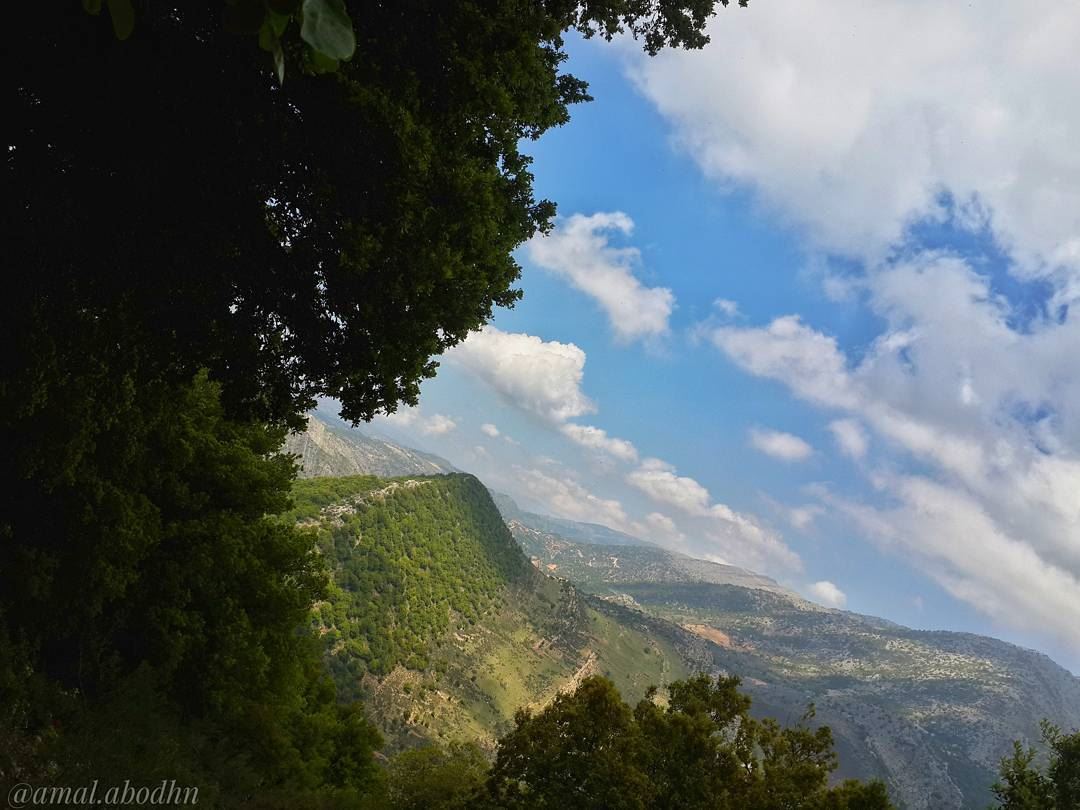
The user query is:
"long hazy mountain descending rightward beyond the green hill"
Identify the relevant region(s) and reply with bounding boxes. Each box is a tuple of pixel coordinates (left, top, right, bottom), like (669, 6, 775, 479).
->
(510, 529, 1080, 810)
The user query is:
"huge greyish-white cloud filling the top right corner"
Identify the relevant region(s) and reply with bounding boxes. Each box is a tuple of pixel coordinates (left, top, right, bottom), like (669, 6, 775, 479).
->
(627, 0, 1080, 282)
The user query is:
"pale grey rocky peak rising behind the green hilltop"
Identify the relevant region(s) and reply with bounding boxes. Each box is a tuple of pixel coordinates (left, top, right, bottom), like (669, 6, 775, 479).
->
(285, 414, 458, 478)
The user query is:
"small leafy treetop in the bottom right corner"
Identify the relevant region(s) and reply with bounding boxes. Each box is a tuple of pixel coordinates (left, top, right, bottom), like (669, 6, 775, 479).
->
(991, 720, 1080, 810)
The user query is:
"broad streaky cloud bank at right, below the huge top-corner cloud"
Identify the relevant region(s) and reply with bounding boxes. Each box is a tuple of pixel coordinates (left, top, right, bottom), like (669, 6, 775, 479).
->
(712, 254, 1080, 649)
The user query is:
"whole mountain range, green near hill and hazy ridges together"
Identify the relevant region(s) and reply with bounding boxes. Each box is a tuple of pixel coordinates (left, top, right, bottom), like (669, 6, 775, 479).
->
(289, 418, 1080, 810)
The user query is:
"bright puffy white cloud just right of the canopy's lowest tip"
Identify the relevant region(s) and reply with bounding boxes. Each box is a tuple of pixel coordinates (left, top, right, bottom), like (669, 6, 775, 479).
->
(445, 326, 596, 422)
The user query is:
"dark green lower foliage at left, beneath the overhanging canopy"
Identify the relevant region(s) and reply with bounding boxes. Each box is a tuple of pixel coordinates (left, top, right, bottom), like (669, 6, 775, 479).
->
(0, 372, 380, 806)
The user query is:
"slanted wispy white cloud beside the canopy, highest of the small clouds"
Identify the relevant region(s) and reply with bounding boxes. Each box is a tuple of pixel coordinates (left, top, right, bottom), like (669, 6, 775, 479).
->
(527, 212, 675, 341)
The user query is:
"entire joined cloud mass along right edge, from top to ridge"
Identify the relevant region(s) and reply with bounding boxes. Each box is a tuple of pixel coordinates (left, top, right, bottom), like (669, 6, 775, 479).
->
(626, 0, 1080, 649)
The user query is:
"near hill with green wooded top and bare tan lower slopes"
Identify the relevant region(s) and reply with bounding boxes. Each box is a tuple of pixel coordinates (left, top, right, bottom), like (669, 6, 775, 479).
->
(287, 474, 689, 748)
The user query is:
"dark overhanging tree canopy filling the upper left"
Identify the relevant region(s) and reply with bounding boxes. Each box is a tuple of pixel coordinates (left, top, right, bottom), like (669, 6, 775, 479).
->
(8, 0, 747, 423)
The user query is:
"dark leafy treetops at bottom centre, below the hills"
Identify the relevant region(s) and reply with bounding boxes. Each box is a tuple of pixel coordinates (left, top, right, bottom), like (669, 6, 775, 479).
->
(488, 675, 892, 810)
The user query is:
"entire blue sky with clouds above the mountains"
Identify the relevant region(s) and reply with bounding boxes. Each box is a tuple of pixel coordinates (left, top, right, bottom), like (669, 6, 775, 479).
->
(352, 0, 1080, 672)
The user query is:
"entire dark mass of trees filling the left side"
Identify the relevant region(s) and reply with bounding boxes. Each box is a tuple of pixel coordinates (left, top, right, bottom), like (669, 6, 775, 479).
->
(0, 0, 743, 807)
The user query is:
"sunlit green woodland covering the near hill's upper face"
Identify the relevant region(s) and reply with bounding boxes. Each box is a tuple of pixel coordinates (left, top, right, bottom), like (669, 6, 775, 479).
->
(295, 475, 531, 685)
